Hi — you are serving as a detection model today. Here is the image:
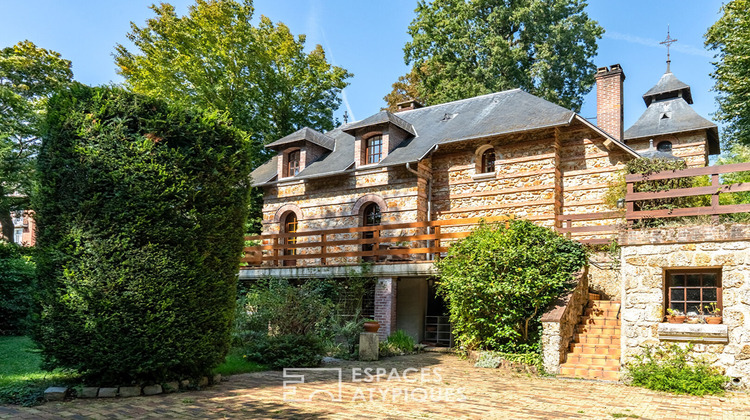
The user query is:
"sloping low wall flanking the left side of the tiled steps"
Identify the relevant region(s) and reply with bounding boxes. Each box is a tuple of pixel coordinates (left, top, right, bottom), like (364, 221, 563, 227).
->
(541, 268, 589, 375)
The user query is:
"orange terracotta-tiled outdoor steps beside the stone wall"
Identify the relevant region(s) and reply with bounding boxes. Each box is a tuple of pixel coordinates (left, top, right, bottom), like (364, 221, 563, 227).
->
(559, 293, 620, 381)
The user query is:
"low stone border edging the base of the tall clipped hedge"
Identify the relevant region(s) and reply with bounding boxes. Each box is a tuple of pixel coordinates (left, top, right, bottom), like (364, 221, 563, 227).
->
(44, 373, 222, 401)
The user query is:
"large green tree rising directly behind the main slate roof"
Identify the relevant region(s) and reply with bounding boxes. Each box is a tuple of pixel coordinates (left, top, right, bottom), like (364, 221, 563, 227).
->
(404, 0, 604, 111)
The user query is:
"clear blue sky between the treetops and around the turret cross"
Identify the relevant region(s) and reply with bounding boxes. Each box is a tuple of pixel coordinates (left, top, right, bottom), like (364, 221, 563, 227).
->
(0, 0, 722, 133)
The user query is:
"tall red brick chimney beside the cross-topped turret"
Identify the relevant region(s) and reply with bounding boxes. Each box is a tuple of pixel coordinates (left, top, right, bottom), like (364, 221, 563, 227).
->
(595, 64, 625, 140)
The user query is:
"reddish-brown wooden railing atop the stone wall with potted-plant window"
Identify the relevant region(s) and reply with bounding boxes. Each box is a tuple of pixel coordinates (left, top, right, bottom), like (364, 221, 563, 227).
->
(625, 162, 750, 223)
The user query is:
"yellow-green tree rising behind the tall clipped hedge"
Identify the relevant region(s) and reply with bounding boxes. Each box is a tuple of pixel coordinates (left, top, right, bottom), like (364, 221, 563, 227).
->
(115, 0, 351, 165)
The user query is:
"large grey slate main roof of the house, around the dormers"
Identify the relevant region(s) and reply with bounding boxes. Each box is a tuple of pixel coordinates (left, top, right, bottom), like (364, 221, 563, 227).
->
(252, 89, 637, 185)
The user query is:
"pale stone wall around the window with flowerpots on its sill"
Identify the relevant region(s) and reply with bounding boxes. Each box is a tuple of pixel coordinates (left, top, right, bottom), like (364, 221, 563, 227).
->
(620, 225, 750, 386)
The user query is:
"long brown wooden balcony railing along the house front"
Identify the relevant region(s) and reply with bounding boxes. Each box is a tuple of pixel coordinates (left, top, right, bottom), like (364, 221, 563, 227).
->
(242, 216, 510, 268)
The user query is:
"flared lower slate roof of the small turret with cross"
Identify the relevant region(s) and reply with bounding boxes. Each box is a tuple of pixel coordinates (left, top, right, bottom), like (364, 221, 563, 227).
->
(624, 98, 720, 155)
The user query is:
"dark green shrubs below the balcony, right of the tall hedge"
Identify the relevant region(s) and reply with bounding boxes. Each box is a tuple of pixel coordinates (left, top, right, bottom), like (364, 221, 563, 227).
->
(234, 267, 373, 368)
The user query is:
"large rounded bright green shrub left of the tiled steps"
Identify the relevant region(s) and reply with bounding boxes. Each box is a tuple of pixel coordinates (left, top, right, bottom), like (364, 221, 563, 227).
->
(437, 220, 586, 353)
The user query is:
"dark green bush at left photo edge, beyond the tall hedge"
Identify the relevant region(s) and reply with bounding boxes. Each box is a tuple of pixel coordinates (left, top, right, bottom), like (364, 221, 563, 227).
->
(0, 240, 35, 335)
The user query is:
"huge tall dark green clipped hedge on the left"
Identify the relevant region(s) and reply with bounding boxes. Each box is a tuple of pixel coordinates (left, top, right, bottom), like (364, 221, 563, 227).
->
(34, 85, 250, 384)
